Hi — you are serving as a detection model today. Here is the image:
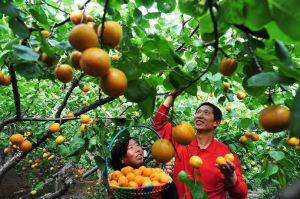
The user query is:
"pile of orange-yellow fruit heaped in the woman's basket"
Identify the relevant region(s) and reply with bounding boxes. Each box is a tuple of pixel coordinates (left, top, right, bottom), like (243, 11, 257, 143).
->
(109, 166, 171, 187)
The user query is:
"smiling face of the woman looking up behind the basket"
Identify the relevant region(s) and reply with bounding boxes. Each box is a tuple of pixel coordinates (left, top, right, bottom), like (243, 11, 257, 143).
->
(122, 139, 144, 168)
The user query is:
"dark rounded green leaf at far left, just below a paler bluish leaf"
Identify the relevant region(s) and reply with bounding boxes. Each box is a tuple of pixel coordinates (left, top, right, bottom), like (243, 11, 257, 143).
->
(14, 63, 41, 79)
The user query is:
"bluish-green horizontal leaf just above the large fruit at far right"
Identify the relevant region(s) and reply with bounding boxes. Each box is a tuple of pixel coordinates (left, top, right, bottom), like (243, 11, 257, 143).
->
(247, 72, 295, 87)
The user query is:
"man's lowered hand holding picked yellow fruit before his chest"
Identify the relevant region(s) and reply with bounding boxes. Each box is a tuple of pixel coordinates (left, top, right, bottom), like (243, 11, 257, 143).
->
(216, 160, 237, 186)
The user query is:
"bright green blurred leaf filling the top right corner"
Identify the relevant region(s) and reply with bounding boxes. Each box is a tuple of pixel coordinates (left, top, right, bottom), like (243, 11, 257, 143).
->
(270, 0, 300, 41)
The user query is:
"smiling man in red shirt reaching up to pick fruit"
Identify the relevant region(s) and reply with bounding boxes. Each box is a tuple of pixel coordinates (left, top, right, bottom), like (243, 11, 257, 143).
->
(153, 92, 248, 199)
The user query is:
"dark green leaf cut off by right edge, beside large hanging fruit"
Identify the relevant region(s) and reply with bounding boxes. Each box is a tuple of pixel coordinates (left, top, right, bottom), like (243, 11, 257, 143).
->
(291, 88, 300, 138)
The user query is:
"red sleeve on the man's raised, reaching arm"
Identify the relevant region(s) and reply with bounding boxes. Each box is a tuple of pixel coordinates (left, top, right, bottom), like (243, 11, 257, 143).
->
(153, 104, 172, 140)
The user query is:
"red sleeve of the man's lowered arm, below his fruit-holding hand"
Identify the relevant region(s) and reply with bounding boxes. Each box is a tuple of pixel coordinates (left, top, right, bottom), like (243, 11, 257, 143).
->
(227, 153, 248, 199)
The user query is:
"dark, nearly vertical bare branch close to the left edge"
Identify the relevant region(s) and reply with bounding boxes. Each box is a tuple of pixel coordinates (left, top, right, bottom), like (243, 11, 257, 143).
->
(7, 64, 21, 118)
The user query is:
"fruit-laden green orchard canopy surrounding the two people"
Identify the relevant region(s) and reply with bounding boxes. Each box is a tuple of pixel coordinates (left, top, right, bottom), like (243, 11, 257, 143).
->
(0, 0, 300, 197)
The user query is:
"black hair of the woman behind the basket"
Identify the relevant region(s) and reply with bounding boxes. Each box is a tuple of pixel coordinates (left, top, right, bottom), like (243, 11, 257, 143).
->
(110, 137, 133, 170)
